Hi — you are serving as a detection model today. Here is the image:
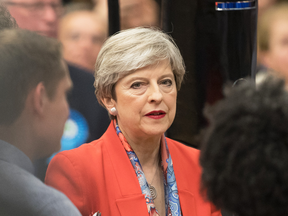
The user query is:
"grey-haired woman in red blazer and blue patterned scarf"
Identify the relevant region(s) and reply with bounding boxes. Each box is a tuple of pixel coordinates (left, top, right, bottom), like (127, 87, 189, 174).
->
(46, 28, 221, 216)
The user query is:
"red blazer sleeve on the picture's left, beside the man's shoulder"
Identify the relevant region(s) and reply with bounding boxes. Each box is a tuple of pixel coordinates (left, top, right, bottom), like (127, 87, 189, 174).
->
(45, 153, 90, 215)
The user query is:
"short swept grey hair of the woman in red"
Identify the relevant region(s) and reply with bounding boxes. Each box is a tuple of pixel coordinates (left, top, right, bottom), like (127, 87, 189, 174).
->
(94, 27, 185, 107)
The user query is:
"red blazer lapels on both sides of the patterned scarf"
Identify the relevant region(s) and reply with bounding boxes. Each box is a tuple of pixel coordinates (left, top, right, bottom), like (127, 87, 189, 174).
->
(103, 122, 196, 216)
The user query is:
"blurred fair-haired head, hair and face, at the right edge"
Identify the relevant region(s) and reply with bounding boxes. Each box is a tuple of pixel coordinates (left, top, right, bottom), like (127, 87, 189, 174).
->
(256, 3, 288, 82)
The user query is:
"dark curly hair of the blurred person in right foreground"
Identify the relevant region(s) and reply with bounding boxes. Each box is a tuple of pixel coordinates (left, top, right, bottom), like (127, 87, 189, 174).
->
(200, 77, 288, 216)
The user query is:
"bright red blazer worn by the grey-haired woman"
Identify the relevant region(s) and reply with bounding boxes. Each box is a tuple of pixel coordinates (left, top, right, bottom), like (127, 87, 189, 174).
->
(45, 124, 221, 216)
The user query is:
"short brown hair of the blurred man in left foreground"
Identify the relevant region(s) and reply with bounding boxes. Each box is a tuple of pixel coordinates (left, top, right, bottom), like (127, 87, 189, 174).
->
(0, 29, 67, 124)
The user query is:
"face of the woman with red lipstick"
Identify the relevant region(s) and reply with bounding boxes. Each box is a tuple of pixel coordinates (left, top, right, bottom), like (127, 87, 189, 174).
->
(113, 61, 177, 139)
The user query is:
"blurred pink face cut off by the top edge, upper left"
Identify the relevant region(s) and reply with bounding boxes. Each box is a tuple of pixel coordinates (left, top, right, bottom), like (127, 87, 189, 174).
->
(6, 0, 62, 38)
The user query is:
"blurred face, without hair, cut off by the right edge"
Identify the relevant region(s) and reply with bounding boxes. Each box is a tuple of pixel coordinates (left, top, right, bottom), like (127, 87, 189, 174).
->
(265, 18, 288, 82)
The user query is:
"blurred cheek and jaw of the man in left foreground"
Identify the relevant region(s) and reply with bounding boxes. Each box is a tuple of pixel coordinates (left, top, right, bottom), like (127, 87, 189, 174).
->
(39, 75, 72, 156)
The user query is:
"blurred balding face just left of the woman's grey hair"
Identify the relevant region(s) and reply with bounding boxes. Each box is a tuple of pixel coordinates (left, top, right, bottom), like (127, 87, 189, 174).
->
(59, 11, 106, 71)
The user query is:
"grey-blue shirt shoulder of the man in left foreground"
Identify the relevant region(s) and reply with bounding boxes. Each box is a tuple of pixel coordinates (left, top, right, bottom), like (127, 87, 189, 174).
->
(0, 161, 80, 216)
